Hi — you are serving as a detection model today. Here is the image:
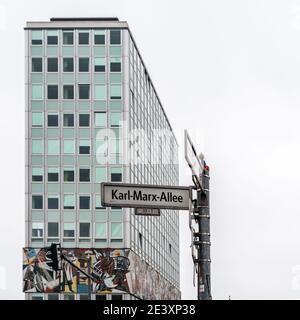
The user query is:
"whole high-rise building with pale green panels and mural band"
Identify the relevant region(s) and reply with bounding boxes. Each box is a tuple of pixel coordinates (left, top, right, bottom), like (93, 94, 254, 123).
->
(24, 18, 180, 300)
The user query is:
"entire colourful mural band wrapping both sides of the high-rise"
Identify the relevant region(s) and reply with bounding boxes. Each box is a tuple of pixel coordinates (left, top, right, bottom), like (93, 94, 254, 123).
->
(23, 248, 180, 300)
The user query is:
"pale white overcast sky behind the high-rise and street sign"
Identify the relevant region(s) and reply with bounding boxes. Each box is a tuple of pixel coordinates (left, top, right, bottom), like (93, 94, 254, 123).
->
(0, 0, 300, 299)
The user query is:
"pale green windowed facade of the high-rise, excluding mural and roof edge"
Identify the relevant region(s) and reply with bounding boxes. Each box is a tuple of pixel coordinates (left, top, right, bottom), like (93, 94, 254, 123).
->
(26, 20, 179, 300)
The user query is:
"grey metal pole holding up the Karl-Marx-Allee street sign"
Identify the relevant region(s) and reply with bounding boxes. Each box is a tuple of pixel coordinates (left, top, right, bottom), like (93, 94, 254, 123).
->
(196, 165, 212, 300)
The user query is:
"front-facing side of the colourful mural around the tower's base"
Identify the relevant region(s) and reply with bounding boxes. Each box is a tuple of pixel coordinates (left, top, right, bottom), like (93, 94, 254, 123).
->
(23, 248, 130, 293)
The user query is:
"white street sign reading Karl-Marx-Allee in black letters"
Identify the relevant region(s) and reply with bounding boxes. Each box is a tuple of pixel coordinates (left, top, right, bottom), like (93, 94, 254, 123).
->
(101, 182, 192, 210)
